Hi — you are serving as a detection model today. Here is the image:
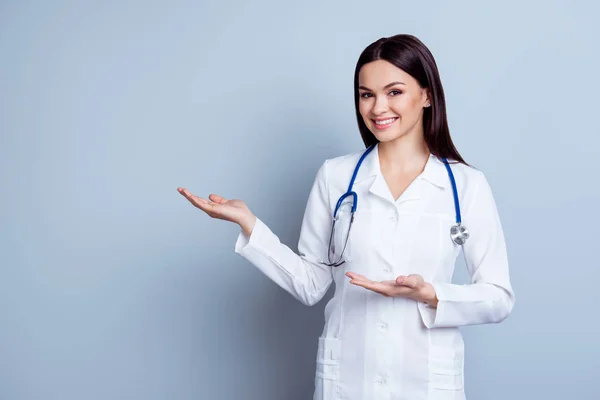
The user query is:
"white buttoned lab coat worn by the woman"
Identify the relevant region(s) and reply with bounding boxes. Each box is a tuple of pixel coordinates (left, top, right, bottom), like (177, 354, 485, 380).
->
(235, 144, 515, 400)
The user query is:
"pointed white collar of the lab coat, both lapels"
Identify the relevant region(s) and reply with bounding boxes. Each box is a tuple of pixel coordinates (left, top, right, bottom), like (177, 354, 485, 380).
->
(354, 143, 450, 189)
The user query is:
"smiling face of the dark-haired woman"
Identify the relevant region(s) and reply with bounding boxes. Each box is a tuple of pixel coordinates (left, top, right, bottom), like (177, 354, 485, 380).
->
(358, 60, 430, 142)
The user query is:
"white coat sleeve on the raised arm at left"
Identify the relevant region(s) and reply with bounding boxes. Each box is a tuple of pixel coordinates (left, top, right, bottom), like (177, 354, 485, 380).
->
(235, 161, 333, 305)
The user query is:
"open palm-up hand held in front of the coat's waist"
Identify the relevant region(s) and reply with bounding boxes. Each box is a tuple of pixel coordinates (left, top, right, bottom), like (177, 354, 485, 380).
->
(346, 272, 438, 307)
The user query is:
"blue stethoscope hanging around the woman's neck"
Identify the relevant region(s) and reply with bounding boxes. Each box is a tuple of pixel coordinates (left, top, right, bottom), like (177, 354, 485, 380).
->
(321, 145, 469, 267)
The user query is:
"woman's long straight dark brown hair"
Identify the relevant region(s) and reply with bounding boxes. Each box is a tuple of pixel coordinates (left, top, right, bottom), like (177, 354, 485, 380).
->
(354, 34, 466, 164)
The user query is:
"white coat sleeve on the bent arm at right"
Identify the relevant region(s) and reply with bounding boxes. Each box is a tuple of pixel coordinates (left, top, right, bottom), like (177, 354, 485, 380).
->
(418, 172, 515, 328)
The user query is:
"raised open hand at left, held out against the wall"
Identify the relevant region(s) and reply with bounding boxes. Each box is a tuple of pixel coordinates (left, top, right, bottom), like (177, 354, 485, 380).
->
(177, 187, 256, 236)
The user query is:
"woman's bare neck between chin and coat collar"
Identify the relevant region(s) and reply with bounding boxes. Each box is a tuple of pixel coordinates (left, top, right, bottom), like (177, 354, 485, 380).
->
(378, 135, 429, 173)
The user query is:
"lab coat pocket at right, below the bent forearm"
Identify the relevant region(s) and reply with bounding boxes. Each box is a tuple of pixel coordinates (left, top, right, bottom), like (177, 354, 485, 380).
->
(429, 347, 464, 391)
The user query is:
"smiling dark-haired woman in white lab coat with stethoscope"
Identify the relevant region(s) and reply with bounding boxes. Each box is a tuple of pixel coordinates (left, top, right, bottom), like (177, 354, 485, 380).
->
(178, 35, 515, 400)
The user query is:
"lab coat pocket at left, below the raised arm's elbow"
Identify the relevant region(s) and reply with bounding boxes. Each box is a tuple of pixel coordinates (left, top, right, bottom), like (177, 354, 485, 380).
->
(314, 337, 341, 400)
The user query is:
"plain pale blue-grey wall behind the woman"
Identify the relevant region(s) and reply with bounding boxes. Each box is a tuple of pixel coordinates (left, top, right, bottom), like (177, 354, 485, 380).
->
(0, 0, 600, 400)
